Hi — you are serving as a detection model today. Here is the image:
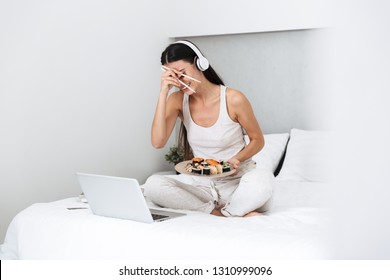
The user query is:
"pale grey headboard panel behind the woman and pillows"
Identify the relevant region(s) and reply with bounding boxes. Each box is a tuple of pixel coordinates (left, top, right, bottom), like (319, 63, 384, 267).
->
(175, 29, 330, 133)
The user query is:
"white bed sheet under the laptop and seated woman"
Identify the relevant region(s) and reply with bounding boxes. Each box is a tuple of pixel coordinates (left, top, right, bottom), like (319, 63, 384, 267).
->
(0, 180, 328, 260)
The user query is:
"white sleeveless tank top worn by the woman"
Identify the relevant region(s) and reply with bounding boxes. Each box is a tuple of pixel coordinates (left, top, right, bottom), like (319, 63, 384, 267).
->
(183, 85, 245, 160)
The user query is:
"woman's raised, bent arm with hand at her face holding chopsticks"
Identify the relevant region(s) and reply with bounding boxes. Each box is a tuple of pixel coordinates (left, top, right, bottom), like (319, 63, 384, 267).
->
(151, 68, 183, 149)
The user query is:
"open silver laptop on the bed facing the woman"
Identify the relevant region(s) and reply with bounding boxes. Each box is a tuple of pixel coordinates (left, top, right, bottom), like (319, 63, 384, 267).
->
(76, 173, 185, 223)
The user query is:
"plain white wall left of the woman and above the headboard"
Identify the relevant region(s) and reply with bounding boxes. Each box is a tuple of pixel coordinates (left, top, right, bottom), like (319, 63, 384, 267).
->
(0, 0, 327, 242)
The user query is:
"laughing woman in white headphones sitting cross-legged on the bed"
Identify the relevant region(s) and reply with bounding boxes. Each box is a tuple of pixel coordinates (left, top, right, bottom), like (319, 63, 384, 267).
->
(145, 41, 274, 217)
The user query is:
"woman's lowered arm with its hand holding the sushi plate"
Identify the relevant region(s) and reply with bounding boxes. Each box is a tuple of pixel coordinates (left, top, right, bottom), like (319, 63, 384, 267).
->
(227, 89, 264, 167)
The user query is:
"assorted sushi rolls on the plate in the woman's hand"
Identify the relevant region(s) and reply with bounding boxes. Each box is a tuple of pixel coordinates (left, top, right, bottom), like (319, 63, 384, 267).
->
(185, 158, 232, 175)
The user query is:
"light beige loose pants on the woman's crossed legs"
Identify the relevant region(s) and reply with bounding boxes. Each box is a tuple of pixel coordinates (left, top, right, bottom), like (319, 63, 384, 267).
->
(144, 162, 275, 217)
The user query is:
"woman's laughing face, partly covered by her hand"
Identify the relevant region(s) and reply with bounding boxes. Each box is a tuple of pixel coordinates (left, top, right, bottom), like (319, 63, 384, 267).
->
(165, 60, 202, 95)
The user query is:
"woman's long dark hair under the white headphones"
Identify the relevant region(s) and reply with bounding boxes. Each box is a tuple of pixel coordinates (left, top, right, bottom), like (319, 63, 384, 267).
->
(161, 42, 224, 160)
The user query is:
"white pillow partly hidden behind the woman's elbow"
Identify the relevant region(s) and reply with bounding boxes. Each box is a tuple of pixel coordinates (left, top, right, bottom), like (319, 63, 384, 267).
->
(244, 133, 289, 173)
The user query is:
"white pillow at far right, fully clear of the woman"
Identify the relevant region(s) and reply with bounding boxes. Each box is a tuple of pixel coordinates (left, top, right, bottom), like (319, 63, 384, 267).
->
(277, 128, 332, 182)
